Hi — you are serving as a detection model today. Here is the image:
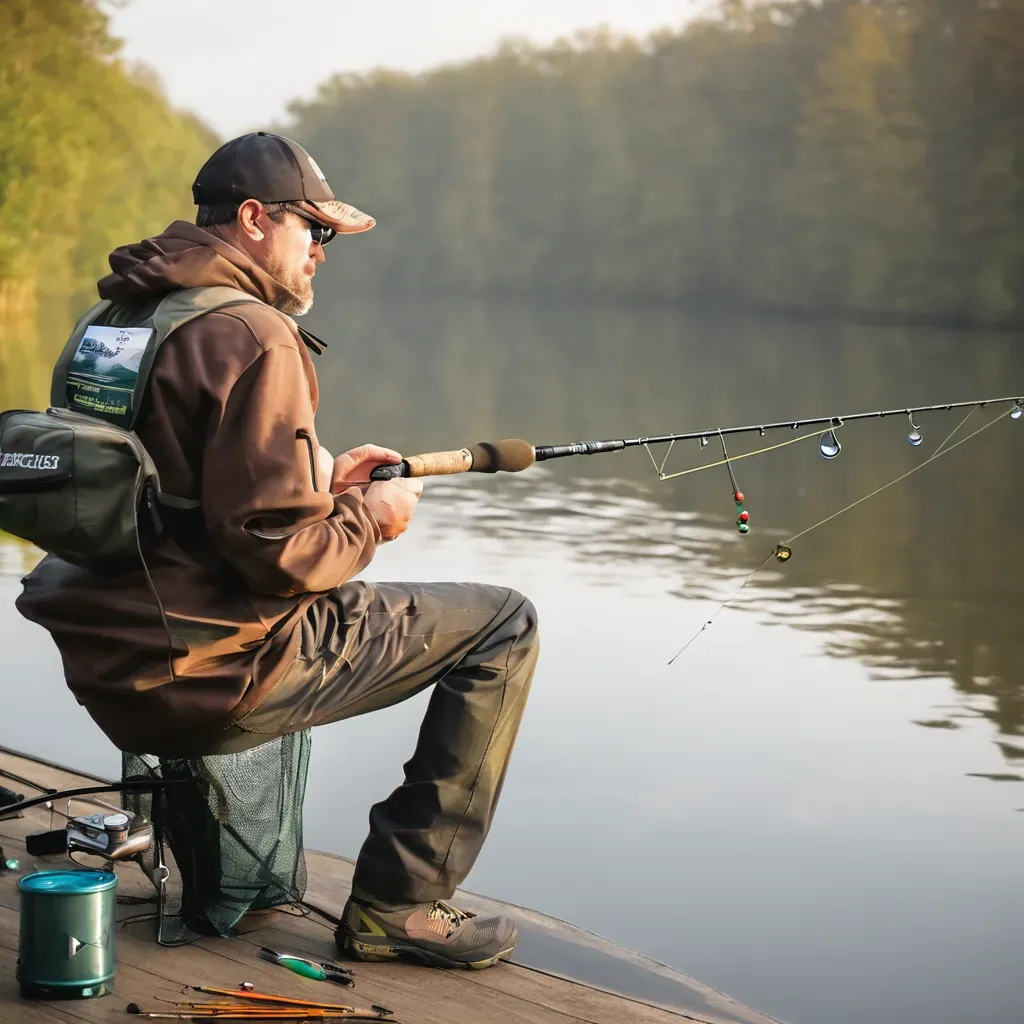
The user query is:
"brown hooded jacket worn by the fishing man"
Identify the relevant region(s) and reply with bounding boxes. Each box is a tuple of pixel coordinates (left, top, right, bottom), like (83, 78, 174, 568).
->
(17, 221, 380, 754)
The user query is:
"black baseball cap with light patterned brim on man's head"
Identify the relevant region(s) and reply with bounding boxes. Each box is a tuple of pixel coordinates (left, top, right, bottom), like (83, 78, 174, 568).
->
(193, 131, 377, 234)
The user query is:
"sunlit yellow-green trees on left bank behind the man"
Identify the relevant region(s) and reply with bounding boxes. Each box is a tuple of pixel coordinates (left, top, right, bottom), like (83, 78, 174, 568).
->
(0, 0, 216, 399)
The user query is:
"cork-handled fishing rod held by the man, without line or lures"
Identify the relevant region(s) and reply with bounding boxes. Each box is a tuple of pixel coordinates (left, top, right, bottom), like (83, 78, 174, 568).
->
(370, 397, 1024, 483)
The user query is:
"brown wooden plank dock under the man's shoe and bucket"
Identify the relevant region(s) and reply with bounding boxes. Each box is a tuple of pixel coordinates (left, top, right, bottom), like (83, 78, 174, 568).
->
(0, 753, 775, 1024)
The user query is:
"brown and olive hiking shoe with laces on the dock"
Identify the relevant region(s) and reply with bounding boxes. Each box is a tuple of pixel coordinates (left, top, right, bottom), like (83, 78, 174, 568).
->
(334, 899, 519, 971)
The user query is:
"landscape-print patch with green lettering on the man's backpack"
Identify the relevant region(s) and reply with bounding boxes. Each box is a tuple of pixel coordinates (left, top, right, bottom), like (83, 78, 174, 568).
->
(67, 327, 154, 427)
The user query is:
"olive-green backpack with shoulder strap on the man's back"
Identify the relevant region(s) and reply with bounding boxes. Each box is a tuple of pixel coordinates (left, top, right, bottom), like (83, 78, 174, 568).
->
(0, 287, 260, 569)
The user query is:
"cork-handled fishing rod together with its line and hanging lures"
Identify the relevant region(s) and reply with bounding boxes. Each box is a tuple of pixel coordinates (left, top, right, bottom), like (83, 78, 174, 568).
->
(370, 387, 1024, 665)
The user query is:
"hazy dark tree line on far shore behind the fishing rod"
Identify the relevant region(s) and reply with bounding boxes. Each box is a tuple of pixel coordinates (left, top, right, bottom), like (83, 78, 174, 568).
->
(286, 0, 1024, 324)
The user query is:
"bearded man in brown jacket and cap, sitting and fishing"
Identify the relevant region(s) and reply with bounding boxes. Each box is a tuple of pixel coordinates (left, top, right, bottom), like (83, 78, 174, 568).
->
(18, 132, 538, 967)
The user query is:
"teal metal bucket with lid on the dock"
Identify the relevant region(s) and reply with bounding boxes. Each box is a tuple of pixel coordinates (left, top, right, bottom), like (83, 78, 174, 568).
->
(17, 871, 118, 999)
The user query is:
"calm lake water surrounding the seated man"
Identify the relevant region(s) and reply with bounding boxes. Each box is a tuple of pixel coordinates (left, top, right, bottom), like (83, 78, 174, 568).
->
(0, 290, 1024, 1024)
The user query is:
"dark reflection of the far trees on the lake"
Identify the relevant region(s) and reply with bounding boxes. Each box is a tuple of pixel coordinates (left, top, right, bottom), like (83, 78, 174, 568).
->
(308, 286, 1024, 778)
